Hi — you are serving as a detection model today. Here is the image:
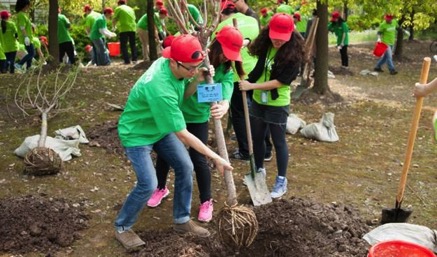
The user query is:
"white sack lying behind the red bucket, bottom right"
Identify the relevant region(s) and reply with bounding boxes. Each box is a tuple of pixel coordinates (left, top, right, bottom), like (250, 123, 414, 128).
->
(363, 223, 437, 253)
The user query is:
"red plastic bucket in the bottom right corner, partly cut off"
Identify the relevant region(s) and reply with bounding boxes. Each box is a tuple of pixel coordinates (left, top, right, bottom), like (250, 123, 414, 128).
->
(367, 240, 436, 257)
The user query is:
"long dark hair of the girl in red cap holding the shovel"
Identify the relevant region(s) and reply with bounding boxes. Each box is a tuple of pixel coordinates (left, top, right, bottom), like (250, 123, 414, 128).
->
(249, 26, 304, 66)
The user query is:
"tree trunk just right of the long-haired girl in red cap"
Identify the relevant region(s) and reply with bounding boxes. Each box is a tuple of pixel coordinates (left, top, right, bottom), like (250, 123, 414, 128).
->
(312, 0, 330, 95)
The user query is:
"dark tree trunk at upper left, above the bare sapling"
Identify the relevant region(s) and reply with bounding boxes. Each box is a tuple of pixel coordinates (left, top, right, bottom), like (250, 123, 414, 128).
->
(49, 0, 59, 67)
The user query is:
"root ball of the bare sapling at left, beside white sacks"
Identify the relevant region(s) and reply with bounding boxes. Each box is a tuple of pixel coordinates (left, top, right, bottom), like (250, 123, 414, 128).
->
(24, 147, 63, 176)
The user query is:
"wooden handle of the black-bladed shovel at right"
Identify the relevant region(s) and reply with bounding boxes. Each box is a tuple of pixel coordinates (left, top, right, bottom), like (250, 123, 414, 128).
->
(396, 57, 431, 208)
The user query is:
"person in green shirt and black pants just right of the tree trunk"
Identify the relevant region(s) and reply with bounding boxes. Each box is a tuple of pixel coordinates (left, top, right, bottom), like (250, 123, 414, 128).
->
(328, 11, 349, 69)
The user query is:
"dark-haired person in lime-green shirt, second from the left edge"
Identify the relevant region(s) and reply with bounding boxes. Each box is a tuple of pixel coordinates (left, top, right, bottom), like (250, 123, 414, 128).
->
(15, 0, 35, 71)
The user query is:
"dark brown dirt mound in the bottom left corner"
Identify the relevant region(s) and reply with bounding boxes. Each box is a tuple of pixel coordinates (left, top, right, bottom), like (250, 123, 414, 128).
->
(0, 196, 88, 253)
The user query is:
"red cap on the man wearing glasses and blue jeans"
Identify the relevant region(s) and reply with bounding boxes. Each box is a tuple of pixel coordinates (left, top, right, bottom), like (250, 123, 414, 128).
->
(162, 34, 204, 63)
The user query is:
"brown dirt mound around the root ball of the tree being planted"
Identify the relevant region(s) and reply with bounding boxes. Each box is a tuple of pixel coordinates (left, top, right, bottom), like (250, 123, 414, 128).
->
(135, 198, 371, 254)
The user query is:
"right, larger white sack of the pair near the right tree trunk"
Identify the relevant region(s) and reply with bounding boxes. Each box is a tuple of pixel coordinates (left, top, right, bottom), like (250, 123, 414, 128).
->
(300, 112, 339, 142)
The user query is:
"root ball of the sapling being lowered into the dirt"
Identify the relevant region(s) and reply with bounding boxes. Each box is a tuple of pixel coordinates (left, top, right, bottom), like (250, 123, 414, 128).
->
(217, 203, 259, 248)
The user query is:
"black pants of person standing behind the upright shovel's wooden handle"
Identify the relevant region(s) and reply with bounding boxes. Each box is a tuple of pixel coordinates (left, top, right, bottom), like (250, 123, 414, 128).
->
(230, 82, 272, 156)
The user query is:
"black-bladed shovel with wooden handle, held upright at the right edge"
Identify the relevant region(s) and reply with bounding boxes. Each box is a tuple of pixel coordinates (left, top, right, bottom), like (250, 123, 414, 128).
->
(381, 57, 431, 224)
